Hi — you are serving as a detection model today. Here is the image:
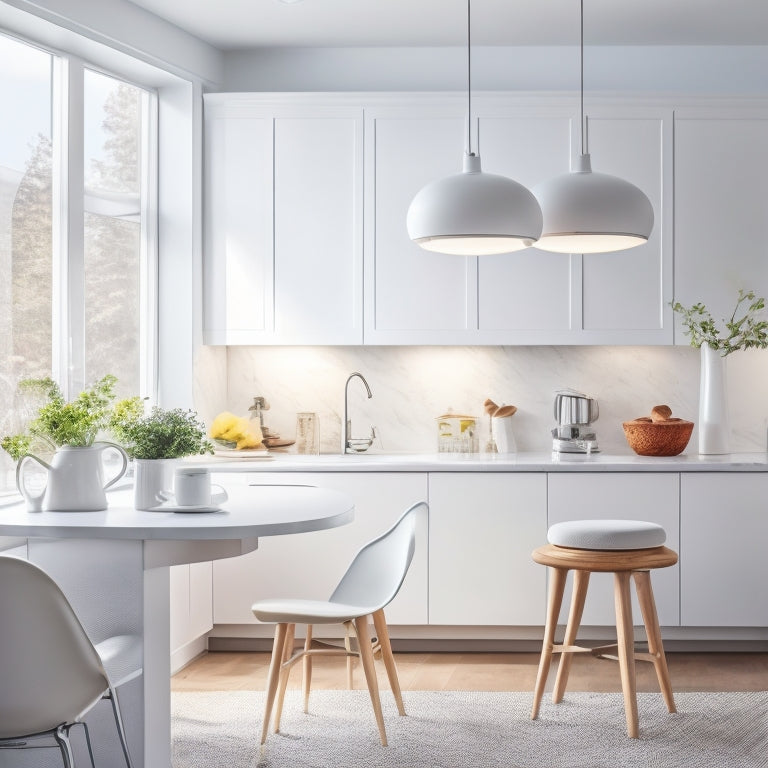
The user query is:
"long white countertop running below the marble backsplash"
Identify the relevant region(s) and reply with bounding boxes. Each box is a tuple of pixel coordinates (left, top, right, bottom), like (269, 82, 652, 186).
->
(196, 452, 768, 472)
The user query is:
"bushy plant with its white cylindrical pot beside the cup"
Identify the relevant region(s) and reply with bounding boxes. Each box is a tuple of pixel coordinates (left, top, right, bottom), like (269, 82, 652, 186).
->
(108, 397, 213, 509)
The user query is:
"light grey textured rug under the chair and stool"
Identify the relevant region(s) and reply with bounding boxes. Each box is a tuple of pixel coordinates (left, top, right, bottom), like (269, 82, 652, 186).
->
(172, 690, 768, 768)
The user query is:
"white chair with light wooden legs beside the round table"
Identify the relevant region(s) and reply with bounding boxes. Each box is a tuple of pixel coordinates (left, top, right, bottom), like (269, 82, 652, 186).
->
(252, 501, 429, 746)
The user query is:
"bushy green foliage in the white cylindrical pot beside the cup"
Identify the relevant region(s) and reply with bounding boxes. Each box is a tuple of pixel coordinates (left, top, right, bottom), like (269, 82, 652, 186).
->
(109, 397, 213, 459)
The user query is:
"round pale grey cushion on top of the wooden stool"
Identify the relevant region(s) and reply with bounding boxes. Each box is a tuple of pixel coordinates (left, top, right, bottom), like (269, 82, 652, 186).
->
(547, 520, 667, 550)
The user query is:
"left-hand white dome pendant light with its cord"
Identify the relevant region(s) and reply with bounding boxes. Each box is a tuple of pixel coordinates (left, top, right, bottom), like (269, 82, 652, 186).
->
(406, 0, 542, 256)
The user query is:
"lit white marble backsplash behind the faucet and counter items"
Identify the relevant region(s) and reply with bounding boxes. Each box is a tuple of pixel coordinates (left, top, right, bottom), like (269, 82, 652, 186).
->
(195, 346, 768, 454)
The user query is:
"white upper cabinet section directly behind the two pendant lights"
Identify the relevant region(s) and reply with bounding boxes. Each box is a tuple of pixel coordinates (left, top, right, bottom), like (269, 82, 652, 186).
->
(365, 95, 672, 345)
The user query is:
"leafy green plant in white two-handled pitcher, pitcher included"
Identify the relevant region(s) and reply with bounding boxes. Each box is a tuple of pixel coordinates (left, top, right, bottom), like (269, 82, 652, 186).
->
(0, 375, 128, 511)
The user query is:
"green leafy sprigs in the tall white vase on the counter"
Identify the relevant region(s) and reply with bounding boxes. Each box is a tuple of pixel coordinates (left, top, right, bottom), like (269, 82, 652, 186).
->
(672, 290, 768, 357)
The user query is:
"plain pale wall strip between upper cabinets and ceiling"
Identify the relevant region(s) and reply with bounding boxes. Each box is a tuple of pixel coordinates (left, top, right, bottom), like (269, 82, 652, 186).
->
(221, 46, 768, 94)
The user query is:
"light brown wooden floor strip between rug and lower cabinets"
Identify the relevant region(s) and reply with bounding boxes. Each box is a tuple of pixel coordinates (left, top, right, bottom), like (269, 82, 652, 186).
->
(171, 652, 768, 692)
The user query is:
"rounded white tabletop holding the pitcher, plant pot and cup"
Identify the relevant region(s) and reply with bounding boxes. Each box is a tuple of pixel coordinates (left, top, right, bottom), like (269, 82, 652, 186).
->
(0, 485, 354, 541)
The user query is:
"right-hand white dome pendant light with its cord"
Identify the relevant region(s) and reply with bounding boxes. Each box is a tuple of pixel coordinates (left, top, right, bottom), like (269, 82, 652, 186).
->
(533, 0, 653, 253)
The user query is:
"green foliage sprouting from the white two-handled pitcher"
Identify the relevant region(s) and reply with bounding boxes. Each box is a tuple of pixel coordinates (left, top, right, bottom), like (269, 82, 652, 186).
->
(0, 374, 117, 461)
